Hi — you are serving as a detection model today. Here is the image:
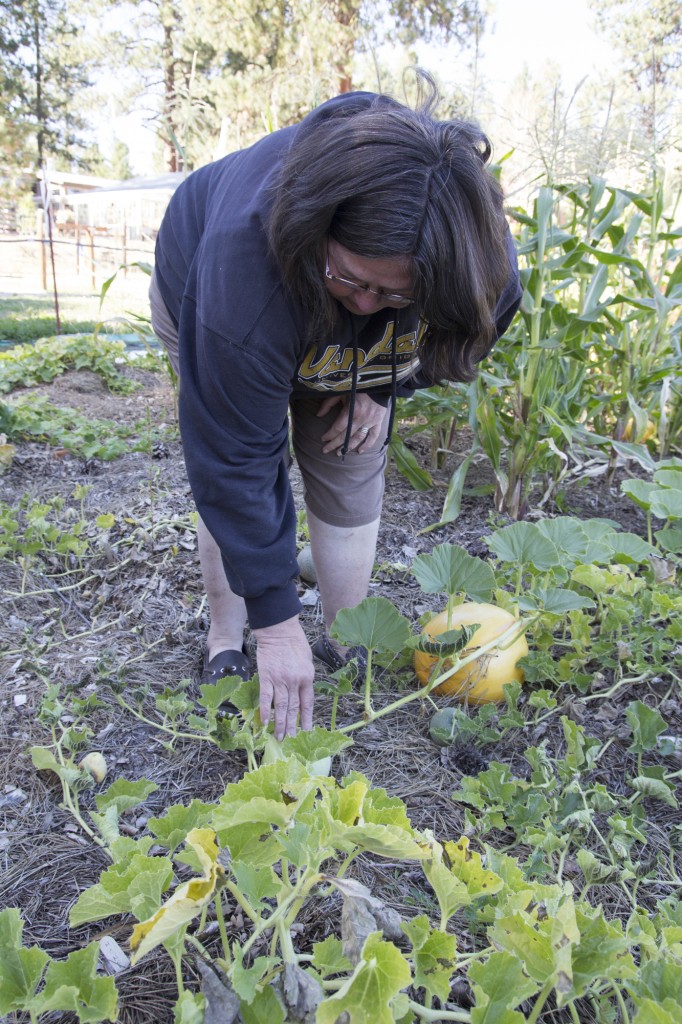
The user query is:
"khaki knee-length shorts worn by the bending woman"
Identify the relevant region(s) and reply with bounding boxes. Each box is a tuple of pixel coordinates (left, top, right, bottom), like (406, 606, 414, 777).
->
(150, 274, 388, 528)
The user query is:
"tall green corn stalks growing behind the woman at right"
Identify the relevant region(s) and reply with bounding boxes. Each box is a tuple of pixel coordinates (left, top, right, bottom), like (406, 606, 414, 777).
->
(395, 177, 682, 522)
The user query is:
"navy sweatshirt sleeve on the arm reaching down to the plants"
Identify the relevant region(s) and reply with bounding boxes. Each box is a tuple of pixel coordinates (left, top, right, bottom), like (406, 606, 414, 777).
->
(179, 276, 301, 629)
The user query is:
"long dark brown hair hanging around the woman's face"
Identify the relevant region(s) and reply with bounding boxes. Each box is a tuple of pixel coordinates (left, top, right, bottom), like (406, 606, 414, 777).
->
(269, 73, 510, 381)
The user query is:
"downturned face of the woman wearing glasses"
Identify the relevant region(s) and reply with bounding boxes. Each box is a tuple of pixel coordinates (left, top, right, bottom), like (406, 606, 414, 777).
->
(325, 239, 414, 316)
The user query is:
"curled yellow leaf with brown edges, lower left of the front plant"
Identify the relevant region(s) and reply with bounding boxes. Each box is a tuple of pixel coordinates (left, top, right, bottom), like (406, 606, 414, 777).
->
(130, 828, 223, 964)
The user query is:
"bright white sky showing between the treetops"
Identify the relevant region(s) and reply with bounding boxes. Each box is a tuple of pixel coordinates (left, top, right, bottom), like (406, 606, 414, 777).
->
(109, 0, 614, 174)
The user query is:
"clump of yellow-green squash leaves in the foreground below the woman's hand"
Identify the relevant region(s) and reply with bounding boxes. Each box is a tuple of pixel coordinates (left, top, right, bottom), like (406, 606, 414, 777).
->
(9, 745, 682, 1024)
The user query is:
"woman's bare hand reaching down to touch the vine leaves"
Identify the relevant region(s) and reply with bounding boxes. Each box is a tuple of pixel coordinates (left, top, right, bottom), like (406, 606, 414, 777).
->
(253, 615, 315, 739)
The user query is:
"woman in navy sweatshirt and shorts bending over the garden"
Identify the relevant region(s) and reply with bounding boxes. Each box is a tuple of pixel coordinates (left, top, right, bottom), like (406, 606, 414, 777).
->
(151, 77, 520, 738)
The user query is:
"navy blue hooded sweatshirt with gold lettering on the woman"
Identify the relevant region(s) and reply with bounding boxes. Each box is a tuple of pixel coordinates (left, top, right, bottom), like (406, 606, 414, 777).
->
(156, 93, 521, 629)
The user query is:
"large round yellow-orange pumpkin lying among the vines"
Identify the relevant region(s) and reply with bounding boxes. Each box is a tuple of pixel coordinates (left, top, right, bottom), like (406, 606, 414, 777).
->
(414, 601, 528, 705)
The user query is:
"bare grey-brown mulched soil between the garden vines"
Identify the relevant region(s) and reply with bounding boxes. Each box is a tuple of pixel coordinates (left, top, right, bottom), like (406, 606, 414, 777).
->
(0, 368, 681, 1024)
